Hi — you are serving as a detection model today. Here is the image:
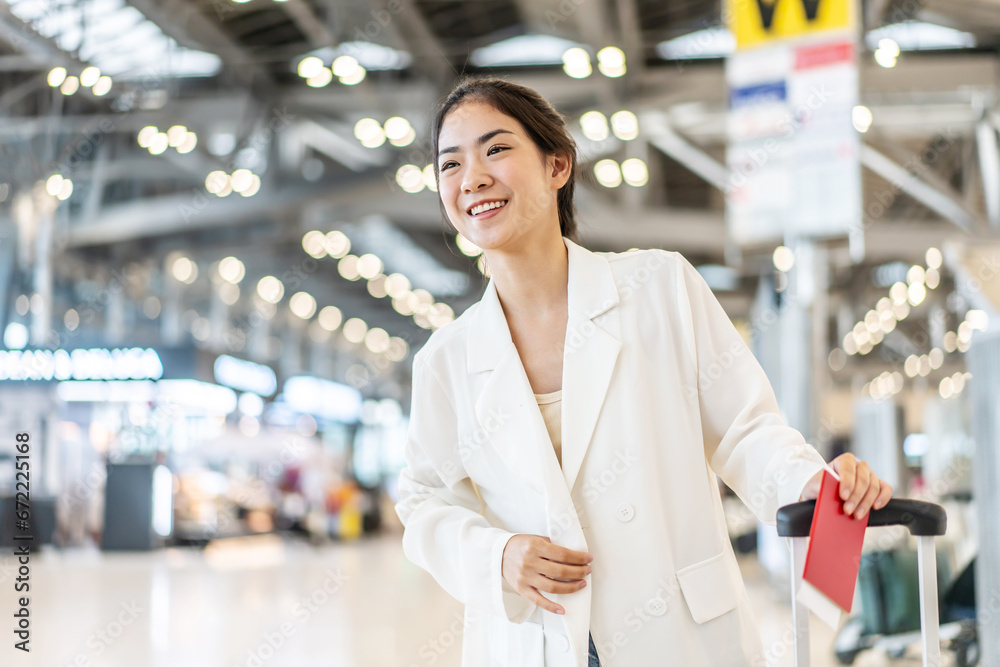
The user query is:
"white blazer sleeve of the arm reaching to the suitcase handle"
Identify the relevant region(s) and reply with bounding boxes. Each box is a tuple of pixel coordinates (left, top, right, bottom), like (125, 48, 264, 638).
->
(677, 254, 825, 525)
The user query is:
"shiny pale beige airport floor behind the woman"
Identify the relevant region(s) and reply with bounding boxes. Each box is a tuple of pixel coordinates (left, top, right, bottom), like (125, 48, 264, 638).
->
(0, 534, 950, 667)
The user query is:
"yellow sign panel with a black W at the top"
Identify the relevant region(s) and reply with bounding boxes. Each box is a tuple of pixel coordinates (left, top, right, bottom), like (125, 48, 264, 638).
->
(726, 0, 857, 49)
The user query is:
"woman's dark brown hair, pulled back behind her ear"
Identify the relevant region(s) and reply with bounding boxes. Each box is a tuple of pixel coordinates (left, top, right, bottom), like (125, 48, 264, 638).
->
(431, 77, 579, 243)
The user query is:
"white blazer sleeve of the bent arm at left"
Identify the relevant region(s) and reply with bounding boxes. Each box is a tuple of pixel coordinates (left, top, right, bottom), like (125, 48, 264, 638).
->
(395, 354, 536, 623)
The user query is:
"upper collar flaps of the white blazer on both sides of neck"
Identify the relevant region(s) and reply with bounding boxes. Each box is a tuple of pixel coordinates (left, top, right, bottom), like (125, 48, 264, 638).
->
(466, 236, 618, 373)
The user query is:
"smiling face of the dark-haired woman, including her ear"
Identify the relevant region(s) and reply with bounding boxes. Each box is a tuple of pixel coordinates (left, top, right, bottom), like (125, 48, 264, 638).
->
(437, 101, 570, 250)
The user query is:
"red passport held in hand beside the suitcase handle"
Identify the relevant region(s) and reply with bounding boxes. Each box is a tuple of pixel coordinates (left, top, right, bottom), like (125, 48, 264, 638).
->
(802, 470, 871, 613)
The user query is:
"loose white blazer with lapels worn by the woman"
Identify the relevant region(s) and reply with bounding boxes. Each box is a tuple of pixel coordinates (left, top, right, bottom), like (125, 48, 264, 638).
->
(396, 238, 824, 667)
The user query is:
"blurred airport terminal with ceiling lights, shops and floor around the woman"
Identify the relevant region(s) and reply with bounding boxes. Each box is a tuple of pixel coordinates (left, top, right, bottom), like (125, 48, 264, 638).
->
(0, 0, 1000, 667)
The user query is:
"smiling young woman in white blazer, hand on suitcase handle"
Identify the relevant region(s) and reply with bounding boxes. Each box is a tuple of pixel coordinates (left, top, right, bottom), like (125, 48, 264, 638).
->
(396, 79, 892, 667)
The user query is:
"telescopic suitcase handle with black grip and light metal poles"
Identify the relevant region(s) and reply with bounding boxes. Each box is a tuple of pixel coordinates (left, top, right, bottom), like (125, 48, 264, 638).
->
(777, 499, 947, 667)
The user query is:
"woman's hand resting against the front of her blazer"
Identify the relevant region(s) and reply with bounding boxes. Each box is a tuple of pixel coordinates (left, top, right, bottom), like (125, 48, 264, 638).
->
(501, 535, 594, 614)
